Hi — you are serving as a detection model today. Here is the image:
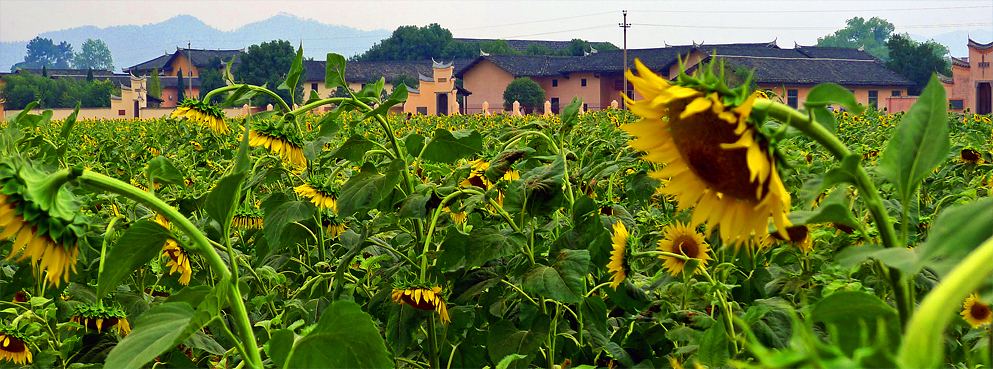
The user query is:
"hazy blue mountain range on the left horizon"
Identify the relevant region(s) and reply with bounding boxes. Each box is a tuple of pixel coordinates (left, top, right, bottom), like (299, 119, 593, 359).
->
(0, 14, 393, 72)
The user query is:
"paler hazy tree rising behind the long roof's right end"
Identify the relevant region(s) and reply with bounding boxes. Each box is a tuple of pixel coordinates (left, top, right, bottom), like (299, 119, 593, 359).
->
(817, 17, 895, 60)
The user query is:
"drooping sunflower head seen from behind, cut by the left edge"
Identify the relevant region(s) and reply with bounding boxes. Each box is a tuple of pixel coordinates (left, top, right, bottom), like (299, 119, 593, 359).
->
(0, 158, 87, 286)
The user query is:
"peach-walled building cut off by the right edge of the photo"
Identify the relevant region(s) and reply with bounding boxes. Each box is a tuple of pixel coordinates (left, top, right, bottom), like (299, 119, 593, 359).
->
(940, 39, 993, 114)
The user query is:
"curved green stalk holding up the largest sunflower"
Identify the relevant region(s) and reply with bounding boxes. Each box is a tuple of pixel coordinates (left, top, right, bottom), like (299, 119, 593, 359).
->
(754, 99, 914, 327)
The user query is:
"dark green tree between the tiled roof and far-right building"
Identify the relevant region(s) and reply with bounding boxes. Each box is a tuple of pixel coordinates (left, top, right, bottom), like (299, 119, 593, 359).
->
(886, 34, 952, 95)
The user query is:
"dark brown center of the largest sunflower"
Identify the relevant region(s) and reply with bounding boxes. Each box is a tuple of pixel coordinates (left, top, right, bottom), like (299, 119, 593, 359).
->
(668, 99, 766, 199)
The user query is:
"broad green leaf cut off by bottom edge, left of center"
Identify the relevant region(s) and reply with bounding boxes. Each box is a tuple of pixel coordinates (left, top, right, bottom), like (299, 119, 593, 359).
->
(283, 301, 394, 368)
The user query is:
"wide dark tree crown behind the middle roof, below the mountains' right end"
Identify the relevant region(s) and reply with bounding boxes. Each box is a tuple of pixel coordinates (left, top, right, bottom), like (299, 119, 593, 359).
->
(355, 23, 452, 61)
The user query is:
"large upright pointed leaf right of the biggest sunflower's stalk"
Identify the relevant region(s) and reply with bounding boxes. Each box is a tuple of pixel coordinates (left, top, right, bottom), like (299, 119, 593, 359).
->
(878, 75, 951, 206)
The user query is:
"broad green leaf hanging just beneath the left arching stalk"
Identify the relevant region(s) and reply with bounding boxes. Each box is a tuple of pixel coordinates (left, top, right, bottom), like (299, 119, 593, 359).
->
(97, 220, 172, 297)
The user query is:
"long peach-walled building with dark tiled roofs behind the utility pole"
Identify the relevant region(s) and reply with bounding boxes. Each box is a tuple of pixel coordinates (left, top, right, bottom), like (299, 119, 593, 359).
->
(455, 42, 913, 113)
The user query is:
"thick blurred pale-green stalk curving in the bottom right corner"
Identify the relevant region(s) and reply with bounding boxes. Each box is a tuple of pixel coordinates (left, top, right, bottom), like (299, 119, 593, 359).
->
(897, 237, 993, 368)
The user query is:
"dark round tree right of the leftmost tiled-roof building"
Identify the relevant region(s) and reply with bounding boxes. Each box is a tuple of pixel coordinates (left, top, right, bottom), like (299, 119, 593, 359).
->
(234, 40, 304, 106)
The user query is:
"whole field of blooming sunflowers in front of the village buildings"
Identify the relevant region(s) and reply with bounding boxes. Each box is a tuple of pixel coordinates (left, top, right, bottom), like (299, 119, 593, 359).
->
(0, 50, 993, 369)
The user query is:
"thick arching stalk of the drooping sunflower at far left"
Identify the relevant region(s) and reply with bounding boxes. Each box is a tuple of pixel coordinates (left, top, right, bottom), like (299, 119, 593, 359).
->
(78, 170, 262, 368)
